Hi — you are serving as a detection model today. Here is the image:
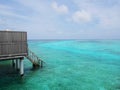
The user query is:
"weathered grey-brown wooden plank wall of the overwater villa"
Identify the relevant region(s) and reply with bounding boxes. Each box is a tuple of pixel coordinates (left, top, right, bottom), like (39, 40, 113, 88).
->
(0, 31, 28, 57)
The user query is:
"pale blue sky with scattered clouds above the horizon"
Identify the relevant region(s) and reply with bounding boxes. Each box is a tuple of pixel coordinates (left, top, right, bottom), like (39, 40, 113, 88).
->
(0, 0, 120, 39)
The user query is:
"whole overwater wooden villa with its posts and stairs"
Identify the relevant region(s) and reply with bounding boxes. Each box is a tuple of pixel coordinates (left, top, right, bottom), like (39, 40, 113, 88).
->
(0, 31, 43, 76)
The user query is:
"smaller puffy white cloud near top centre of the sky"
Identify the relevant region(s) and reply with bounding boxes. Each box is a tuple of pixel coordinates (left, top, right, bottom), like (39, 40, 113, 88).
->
(52, 2, 69, 14)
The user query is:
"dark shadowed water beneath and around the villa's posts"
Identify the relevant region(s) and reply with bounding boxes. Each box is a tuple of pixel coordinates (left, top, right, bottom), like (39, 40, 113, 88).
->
(0, 61, 43, 90)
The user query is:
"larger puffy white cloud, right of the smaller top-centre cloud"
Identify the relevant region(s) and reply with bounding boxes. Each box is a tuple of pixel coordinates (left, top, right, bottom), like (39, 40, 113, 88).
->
(72, 10, 92, 23)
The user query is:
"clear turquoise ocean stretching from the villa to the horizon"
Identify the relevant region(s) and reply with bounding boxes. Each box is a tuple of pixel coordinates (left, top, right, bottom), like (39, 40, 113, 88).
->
(0, 40, 120, 90)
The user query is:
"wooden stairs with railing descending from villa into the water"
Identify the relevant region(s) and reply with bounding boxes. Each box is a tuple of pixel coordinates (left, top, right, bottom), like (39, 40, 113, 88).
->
(26, 49, 44, 67)
